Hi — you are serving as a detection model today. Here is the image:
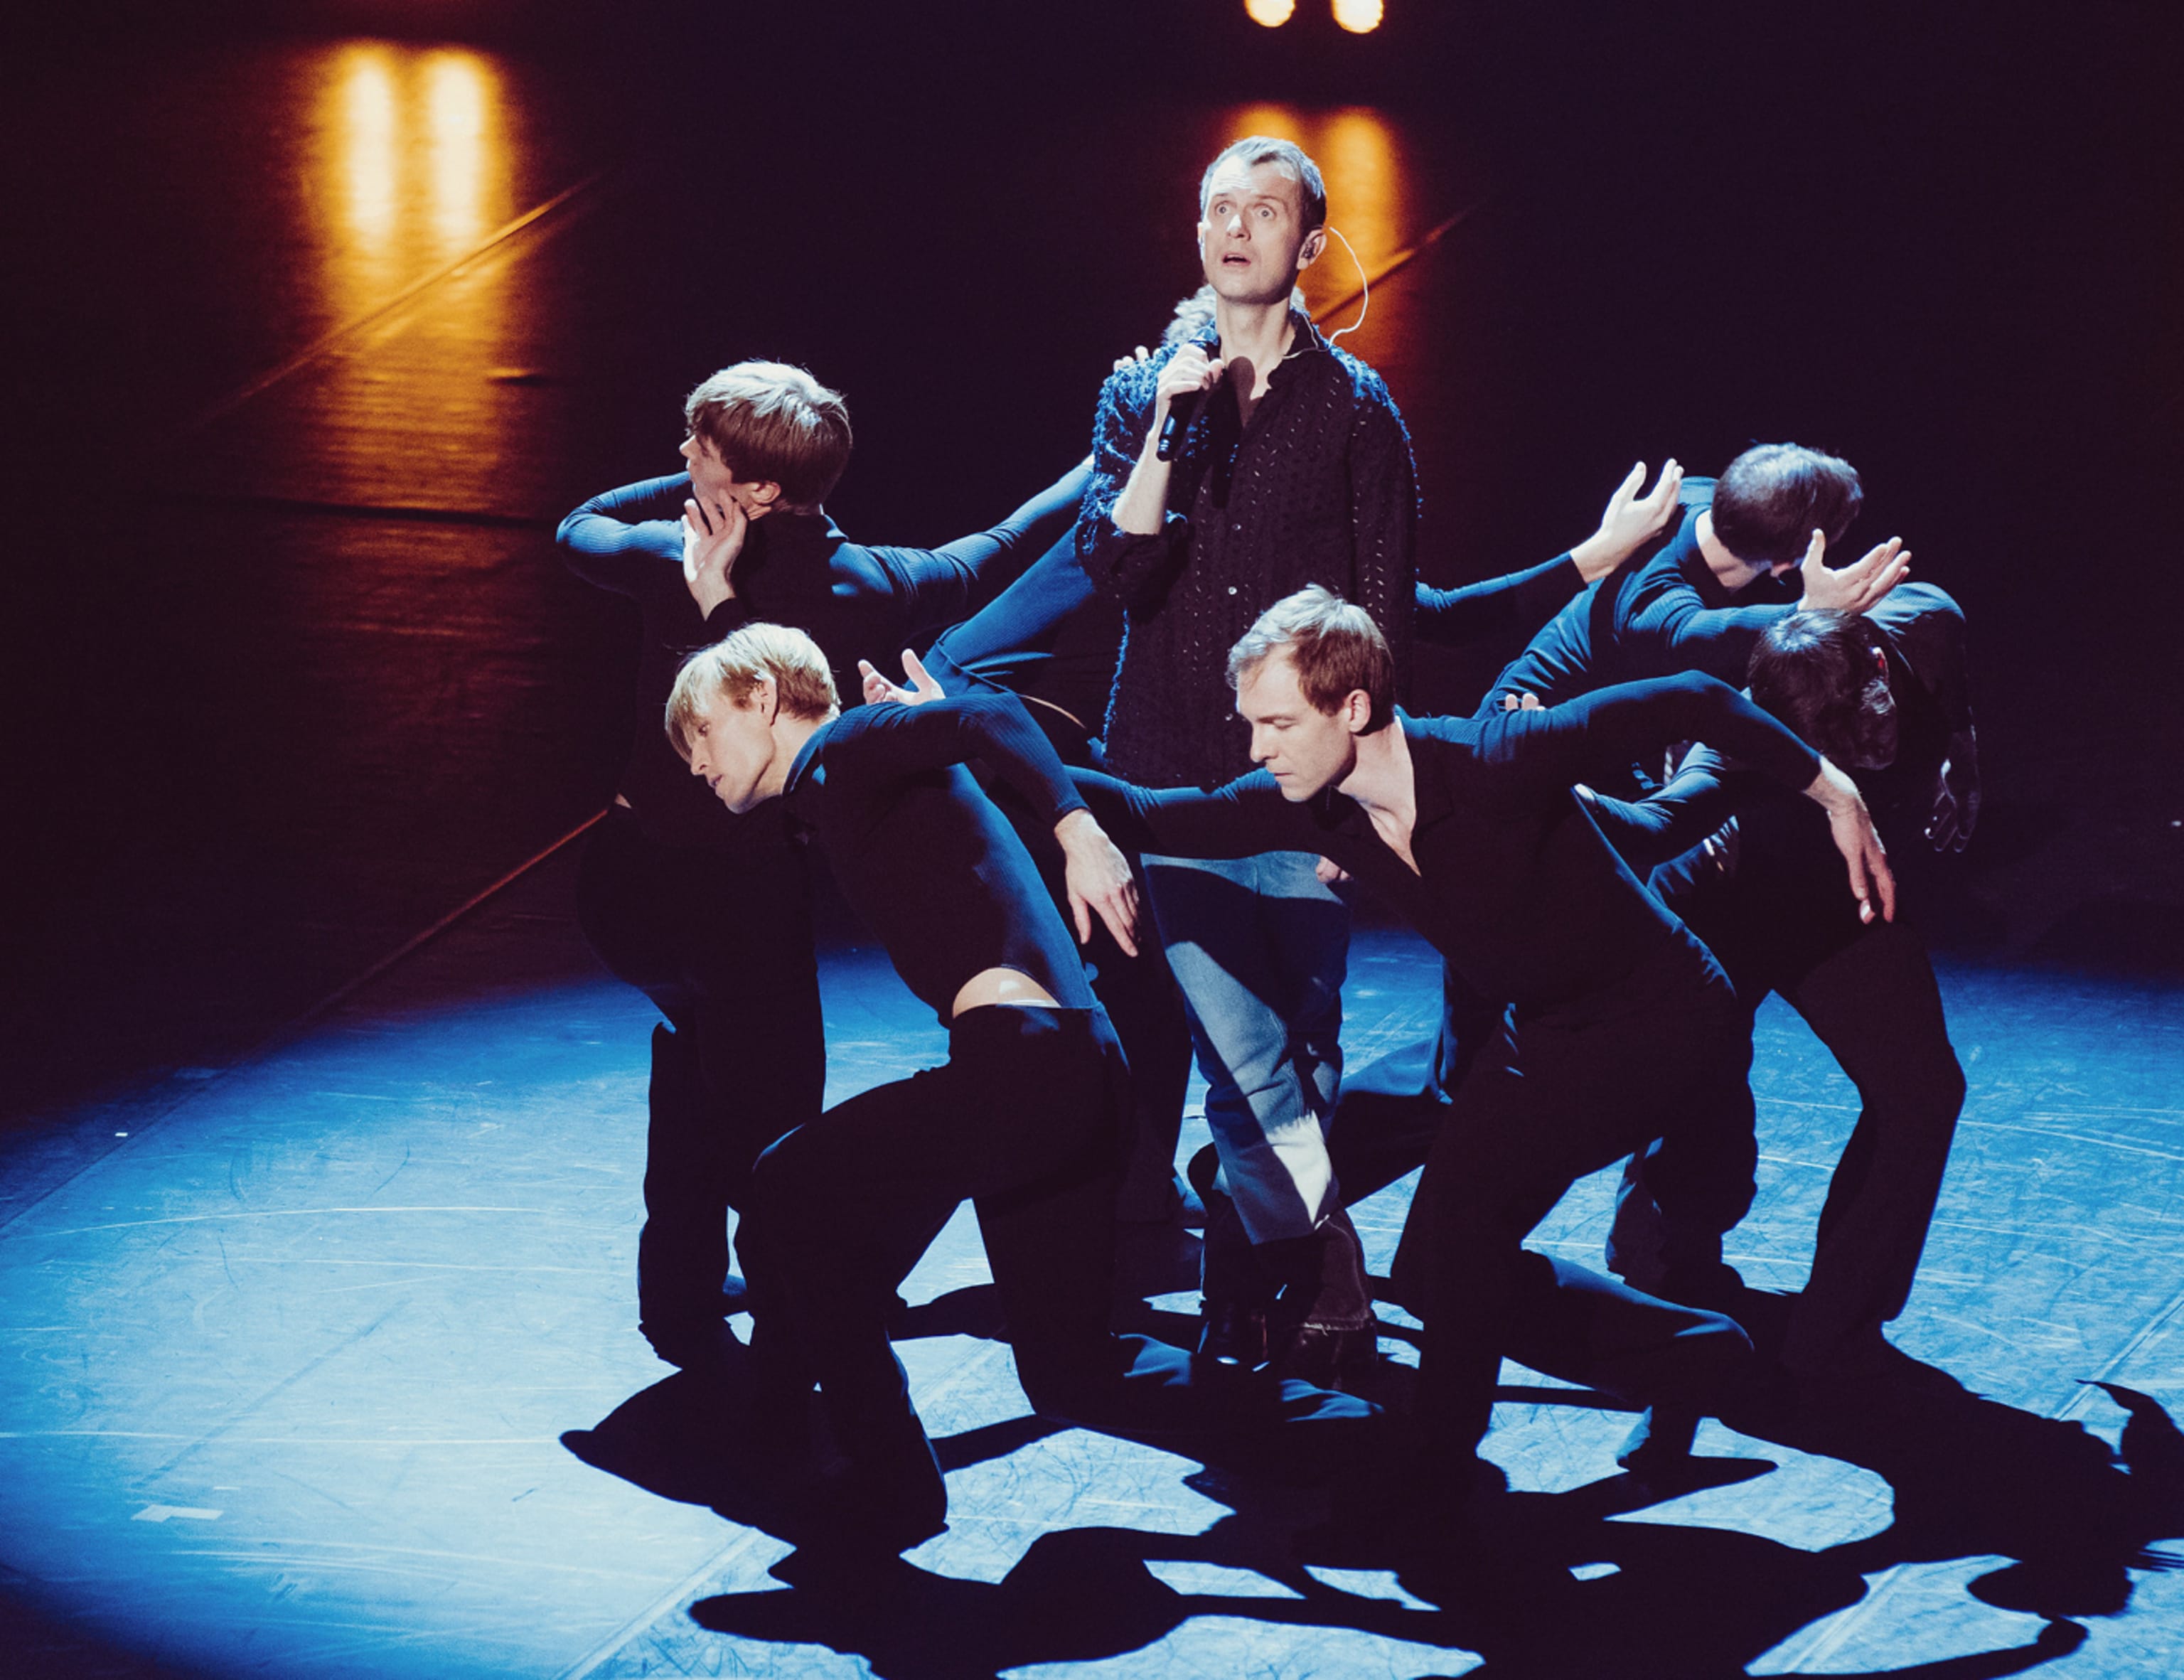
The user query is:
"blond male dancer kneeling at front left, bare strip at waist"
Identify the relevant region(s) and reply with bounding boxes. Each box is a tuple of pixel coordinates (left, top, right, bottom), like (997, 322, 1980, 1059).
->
(668, 625, 1378, 1549)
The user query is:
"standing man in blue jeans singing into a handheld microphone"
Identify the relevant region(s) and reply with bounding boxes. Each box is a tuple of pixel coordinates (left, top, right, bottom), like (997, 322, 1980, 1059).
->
(1076, 138, 1418, 1383)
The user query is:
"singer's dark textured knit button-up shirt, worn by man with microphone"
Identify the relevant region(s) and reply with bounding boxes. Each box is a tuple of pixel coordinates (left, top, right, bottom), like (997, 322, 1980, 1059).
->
(1076, 310, 1418, 788)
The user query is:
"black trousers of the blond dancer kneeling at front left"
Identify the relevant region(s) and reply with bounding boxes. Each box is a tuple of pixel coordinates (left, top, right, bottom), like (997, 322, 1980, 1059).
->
(736, 1005, 1378, 1509)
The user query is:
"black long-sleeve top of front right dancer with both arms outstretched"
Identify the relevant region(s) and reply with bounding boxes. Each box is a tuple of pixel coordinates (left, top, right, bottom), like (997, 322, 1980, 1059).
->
(1074, 673, 1819, 1016)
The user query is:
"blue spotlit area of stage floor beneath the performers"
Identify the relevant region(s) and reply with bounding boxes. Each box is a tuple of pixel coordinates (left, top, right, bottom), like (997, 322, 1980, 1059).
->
(0, 859, 2184, 1680)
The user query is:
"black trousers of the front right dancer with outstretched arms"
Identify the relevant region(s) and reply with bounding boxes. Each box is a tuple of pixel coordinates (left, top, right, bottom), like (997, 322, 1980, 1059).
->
(1398, 935, 1752, 1481)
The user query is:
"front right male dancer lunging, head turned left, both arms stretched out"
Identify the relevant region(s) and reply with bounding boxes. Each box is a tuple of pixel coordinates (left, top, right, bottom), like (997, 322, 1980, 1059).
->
(1056, 590, 1893, 1499)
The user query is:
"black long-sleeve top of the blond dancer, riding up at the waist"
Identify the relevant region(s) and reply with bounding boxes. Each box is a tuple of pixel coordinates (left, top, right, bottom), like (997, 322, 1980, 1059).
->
(782, 695, 1092, 1024)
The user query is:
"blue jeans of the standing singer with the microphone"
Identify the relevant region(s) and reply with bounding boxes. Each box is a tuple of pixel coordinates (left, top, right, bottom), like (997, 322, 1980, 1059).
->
(1145, 852, 1349, 1243)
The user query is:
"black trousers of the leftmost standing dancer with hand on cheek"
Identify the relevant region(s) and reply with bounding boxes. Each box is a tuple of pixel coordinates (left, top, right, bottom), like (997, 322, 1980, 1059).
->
(577, 806, 825, 1330)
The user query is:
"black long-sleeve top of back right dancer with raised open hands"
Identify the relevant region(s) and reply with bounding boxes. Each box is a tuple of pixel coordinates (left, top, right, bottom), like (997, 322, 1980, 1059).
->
(1479, 478, 1799, 717)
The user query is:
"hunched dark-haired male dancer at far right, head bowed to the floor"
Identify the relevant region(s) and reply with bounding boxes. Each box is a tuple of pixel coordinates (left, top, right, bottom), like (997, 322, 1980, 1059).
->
(1597, 583, 1979, 1376)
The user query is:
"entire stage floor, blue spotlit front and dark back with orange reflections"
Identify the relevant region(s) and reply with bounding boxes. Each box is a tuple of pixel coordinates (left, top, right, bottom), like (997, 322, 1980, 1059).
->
(0, 16, 2184, 1680)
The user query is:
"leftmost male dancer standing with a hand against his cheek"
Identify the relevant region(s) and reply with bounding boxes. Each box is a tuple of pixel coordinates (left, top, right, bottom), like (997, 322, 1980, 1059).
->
(559, 363, 1083, 1366)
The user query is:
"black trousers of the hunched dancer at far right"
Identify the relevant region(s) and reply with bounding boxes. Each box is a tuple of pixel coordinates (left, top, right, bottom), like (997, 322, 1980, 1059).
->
(1610, 900, 1964, 1370)
